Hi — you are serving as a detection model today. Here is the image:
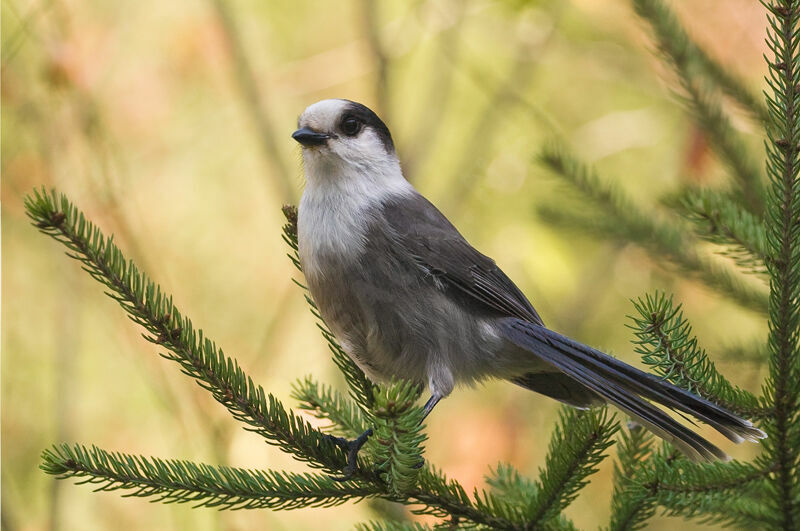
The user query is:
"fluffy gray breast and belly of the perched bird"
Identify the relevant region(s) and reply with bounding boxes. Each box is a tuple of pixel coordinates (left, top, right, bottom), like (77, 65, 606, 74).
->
(308, 203, 499, 395)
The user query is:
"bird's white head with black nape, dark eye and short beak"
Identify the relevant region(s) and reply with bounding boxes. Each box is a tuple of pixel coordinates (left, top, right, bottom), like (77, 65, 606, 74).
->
(292, 99, 399, 181)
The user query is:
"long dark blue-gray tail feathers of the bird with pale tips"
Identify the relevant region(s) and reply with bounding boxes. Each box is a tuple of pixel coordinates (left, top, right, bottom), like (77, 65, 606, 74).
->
(499, 318, 766, 461)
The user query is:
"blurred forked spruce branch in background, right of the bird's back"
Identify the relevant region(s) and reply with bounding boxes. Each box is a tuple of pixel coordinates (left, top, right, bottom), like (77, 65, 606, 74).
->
(539, 145, 767, 312)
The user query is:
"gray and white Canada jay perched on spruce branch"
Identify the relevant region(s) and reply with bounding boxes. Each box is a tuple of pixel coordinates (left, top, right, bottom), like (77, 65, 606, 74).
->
(292, 99, 766, 474)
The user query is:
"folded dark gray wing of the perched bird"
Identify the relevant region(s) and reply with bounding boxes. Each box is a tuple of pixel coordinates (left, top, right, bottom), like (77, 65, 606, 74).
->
(383, 193, 543, 325)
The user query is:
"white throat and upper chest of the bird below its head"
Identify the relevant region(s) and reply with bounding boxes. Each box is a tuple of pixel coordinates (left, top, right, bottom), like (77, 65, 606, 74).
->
(297, 149, 414, 278)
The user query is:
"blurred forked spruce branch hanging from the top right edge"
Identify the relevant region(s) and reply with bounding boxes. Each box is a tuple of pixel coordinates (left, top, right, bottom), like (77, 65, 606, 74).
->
(633, 0, 766, 213)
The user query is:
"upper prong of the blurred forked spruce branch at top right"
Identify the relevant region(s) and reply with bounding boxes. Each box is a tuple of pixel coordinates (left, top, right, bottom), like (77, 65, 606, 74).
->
(633, 0, 769, 124)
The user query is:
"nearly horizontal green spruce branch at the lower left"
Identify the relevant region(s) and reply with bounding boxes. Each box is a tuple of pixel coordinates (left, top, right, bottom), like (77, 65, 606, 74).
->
(40, 444, 378, 510)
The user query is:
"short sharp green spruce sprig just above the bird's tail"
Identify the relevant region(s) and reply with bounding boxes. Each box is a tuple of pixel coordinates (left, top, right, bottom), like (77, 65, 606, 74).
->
(628, 292, 771, 419)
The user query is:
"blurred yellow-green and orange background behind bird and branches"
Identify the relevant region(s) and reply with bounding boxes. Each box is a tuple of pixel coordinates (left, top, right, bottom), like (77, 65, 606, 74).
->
(2, 0, 766, 530)
